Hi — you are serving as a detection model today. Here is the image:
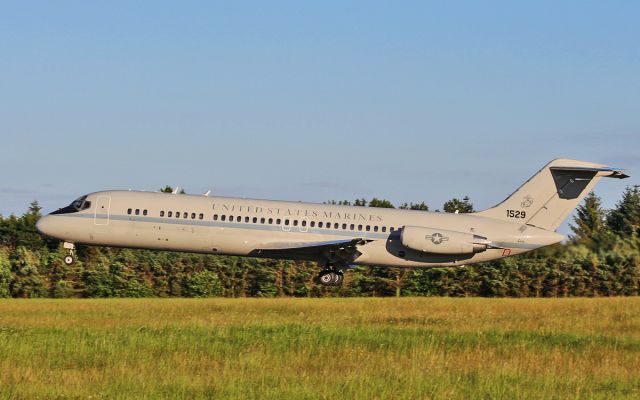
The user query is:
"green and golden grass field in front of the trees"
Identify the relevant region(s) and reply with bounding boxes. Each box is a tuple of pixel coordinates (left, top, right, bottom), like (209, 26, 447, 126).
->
(0, 298, 640, 399)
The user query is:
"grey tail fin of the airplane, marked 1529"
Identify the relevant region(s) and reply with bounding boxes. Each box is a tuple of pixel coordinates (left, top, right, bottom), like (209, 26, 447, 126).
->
(476, 159, 628, 231)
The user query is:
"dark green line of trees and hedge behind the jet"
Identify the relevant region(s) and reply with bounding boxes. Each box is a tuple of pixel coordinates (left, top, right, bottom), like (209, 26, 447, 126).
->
(0, 186, 640, 298)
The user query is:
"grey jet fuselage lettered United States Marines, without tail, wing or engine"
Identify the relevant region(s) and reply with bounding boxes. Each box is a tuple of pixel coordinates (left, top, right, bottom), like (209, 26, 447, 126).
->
(38, 191, 564, 267)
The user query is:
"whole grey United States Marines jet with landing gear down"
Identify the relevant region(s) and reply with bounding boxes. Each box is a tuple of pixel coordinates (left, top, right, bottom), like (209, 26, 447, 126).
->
(36, 159, 628, 286)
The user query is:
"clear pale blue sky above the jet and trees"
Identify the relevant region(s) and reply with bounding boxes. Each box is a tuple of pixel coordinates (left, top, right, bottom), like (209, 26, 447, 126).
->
(0, 1, 640, 234)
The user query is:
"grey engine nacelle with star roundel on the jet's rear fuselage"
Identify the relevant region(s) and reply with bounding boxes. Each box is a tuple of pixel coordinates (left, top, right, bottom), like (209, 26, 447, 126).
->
(400, 226, 491, 254)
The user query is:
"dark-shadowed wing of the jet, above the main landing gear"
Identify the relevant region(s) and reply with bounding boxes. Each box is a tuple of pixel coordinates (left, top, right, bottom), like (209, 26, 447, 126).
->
(250, 238, 371, 265)
